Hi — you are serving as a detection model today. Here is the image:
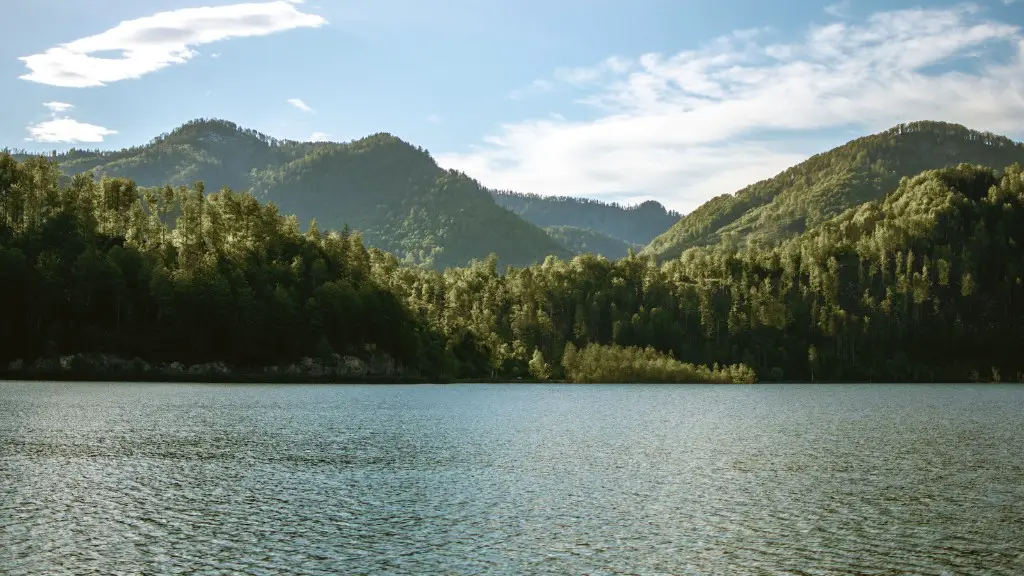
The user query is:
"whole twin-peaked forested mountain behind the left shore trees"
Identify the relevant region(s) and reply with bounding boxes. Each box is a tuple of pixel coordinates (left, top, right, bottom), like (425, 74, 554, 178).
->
(24, 120, 571, 268)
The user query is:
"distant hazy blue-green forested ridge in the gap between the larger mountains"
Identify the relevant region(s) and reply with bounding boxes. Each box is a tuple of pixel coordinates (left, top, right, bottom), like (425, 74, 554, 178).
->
(492, 191, 682, 245)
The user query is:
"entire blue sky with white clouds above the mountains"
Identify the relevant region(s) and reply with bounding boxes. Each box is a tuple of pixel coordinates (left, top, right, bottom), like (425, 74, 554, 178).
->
(0, 0, 1024, 212)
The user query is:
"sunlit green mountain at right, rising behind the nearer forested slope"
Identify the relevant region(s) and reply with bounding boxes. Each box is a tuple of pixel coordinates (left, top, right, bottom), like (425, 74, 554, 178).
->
(642, 122, 1024, 260)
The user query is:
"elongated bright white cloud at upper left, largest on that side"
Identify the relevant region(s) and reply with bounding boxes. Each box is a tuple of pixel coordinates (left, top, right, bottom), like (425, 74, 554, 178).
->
(20, 0, 327, 88)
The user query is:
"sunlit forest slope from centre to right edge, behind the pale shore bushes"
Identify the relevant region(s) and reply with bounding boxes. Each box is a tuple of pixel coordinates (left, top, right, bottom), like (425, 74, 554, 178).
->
(377, 159, 1024, 381)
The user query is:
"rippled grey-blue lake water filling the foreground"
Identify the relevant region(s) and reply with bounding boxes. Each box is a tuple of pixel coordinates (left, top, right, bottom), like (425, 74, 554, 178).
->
(0, 383, 1024, 575)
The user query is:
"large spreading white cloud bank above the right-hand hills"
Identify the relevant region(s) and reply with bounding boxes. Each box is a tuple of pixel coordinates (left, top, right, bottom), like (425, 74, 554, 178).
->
(437, 6, 1024, 211)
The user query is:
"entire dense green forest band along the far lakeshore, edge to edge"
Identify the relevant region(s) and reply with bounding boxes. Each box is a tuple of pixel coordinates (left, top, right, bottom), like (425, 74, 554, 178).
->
(0, 145, 1024, 381)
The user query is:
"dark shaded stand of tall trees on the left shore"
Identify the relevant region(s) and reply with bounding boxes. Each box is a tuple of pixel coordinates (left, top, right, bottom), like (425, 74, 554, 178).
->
(0, 155, 445, 374)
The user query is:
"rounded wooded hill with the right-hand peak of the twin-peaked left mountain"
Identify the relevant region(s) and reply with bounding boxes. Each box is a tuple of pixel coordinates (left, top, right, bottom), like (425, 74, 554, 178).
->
(244, 134, 569, 269)
